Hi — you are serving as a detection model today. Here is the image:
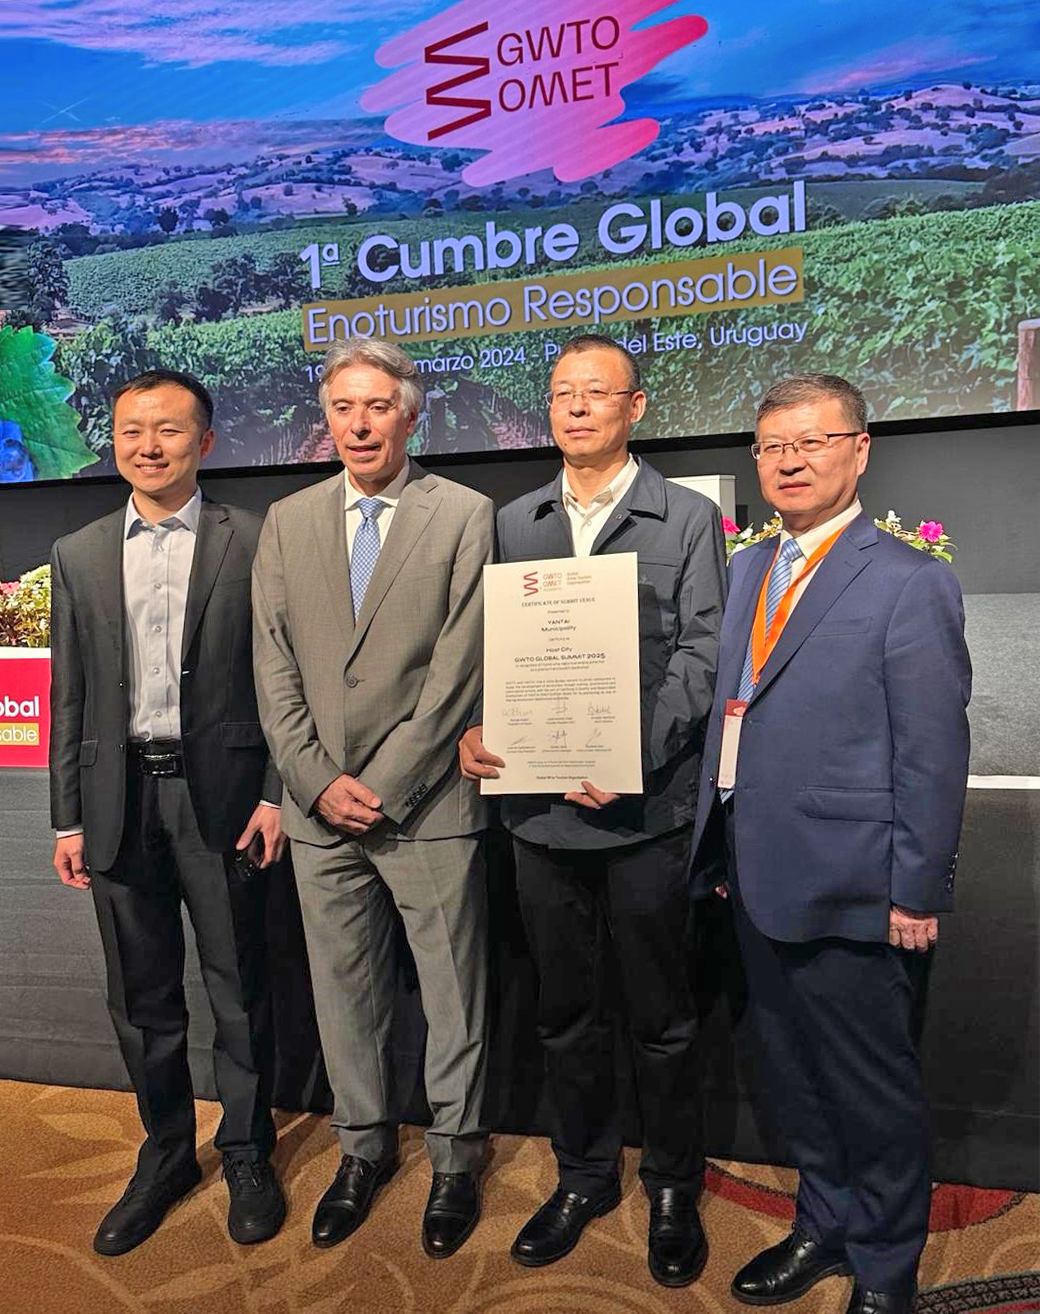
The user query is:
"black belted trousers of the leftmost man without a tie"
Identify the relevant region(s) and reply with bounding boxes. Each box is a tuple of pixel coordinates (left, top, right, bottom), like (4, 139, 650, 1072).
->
(91, 767, 275, 1181)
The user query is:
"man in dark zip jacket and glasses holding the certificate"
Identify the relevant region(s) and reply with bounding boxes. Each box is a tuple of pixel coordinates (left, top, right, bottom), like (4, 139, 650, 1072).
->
(460, 335, 726, 1286)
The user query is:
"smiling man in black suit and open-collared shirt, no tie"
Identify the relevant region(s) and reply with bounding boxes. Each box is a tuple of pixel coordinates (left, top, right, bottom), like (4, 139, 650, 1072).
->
(50, 369, 285, 1255)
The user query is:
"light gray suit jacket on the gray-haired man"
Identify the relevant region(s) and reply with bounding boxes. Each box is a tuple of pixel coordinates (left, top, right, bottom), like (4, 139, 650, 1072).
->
(252, 461, 494, 845)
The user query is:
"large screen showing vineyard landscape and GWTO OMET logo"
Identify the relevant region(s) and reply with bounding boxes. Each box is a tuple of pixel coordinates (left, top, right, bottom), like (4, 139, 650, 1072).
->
(0, 0, 1040, 484)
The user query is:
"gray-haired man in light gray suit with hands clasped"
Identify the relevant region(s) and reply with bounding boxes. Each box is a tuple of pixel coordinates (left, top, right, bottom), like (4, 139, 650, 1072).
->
(252, 338, 494, 1257)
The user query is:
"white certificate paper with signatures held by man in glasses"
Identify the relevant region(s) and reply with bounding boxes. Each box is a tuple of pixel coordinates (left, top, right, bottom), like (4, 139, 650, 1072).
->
(480, 552, 643, 794)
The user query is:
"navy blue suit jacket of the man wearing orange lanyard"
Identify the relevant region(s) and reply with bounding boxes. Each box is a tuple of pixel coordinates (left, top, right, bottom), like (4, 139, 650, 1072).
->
(694, 515, 972, 942)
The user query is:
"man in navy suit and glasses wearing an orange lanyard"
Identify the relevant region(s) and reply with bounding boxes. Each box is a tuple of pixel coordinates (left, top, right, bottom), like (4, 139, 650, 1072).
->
(696, 374, 970, 1314)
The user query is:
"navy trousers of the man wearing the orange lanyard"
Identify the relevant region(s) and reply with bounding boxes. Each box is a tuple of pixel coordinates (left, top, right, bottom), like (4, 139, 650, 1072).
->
(727, 809, 931, 1294)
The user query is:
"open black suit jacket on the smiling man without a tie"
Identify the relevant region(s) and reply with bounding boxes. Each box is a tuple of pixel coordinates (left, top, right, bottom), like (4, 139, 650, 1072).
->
(50, 499, 281, 871)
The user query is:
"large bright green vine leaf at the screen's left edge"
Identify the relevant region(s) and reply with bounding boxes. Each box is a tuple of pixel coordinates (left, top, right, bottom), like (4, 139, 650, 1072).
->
(0, 325, 97, 480)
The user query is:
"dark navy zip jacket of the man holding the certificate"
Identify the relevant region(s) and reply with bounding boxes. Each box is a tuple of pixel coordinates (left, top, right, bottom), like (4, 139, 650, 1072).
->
(488, 460, 726, 849)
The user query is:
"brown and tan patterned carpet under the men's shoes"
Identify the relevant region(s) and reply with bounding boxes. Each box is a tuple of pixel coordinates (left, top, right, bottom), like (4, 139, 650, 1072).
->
(0, 1081, 1040, 1314)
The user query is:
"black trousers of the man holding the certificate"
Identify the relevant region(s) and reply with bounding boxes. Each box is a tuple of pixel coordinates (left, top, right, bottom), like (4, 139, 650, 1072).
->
(514, 830, 703, 1194)
